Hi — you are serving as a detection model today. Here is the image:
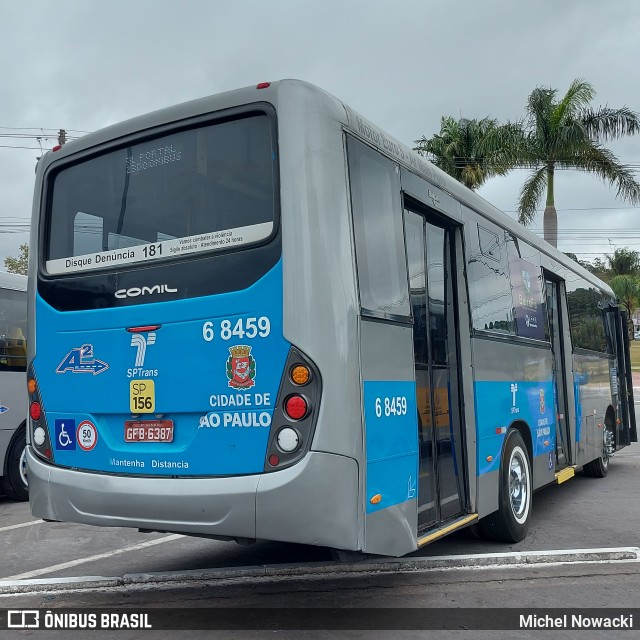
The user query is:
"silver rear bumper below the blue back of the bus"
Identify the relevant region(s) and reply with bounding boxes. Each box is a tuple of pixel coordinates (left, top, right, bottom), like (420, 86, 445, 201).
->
(27, 447, 360, 549)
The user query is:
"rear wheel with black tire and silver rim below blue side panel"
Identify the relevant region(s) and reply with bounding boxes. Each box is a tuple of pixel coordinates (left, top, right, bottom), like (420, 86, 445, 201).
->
(479, 429, 532, 542)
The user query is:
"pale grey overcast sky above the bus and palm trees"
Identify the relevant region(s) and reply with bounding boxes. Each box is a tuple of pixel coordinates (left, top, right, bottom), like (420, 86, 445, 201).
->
(0, 0, 640, 270)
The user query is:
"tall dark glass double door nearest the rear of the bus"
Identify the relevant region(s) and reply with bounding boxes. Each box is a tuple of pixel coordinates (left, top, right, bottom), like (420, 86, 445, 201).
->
(404, 207, 466, 533)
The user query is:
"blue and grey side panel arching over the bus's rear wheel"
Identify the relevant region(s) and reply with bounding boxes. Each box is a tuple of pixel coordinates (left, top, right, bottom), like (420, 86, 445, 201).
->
(473, 338, 555, 517)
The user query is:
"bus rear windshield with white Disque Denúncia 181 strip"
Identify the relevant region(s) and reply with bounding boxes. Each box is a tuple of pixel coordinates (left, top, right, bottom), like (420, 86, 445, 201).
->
(45, 114, 275, 274)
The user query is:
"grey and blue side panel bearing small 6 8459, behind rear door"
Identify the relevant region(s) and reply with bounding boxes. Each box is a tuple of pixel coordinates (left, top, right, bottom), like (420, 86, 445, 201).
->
(360, 319, 418, 556)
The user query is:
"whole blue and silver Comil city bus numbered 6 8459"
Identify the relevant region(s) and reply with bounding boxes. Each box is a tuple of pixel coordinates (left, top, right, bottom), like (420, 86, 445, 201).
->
(27, 80, 637, 556)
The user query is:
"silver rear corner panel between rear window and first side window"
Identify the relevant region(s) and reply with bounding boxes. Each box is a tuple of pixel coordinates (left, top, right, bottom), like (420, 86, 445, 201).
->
(278, 83, 362, 460)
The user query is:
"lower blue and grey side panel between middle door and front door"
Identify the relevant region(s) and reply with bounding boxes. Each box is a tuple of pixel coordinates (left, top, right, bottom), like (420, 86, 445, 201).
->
(573, 353, 613, 466)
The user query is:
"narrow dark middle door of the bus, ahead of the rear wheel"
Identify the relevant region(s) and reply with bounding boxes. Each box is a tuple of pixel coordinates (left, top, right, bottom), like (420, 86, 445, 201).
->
(545, 275, 571, 471)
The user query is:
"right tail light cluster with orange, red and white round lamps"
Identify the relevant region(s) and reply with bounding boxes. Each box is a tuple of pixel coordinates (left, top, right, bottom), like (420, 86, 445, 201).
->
(264, 347, 322, 471)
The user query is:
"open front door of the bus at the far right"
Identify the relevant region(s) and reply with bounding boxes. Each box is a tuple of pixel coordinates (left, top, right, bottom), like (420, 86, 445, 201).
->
(606, 305, 637, 447)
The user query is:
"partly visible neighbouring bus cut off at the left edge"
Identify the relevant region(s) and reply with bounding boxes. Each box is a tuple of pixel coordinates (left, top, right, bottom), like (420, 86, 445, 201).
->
(0, 272, 29, 501)
